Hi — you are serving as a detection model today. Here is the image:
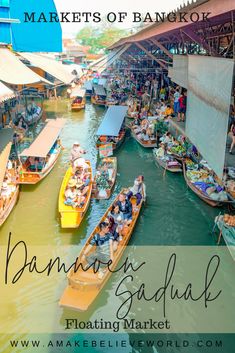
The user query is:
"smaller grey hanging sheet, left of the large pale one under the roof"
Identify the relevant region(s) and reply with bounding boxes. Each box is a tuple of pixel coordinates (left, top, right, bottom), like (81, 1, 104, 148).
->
(168, 55, 188, 88)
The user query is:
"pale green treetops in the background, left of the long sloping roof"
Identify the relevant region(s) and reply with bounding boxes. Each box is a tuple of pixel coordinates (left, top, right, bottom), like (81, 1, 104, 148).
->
(76, 26, 128, 54)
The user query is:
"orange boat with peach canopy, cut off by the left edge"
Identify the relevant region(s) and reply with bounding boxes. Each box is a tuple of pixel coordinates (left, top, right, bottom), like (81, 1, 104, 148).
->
(0, 129, 19, 226)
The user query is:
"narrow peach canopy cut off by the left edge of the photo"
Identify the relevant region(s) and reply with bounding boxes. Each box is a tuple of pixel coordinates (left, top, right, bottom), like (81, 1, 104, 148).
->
(0, 129, 14, 190)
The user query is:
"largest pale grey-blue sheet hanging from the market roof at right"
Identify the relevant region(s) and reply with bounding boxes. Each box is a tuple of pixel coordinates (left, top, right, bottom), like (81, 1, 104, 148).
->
(186, 55, 234, 178)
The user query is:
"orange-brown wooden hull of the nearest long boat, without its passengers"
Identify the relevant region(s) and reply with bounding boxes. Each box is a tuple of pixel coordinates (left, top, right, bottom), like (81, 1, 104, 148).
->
(59, 191, 142, 311)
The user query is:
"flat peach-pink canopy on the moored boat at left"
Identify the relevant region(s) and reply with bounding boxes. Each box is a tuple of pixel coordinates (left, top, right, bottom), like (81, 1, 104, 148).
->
(19, 118, 65, 158)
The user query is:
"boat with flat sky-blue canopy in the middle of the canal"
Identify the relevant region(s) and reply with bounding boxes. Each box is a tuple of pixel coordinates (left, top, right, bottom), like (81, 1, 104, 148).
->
(96, 105, 127, 150)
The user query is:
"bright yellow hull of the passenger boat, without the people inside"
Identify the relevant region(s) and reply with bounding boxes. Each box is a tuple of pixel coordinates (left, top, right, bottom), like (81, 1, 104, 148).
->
(59, 161, 92, 228)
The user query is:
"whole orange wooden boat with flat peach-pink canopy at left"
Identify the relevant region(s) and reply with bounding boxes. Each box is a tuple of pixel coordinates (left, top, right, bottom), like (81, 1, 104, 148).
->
(19, 119, 64, 184)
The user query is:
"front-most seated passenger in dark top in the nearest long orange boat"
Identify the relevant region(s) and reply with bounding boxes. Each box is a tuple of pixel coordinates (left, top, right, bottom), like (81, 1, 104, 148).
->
(81, 222, 114, 278)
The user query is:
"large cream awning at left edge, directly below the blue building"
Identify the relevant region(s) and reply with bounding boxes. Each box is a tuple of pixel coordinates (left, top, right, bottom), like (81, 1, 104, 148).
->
(0, 48, 51, 85)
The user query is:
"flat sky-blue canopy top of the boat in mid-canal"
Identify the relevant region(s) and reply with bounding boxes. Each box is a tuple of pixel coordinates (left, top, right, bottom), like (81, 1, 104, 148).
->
(96, 105, 128, 136)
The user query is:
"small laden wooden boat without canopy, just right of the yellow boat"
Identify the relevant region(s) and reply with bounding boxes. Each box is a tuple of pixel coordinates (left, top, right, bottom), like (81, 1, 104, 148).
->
(92, 157, 117, 200)
